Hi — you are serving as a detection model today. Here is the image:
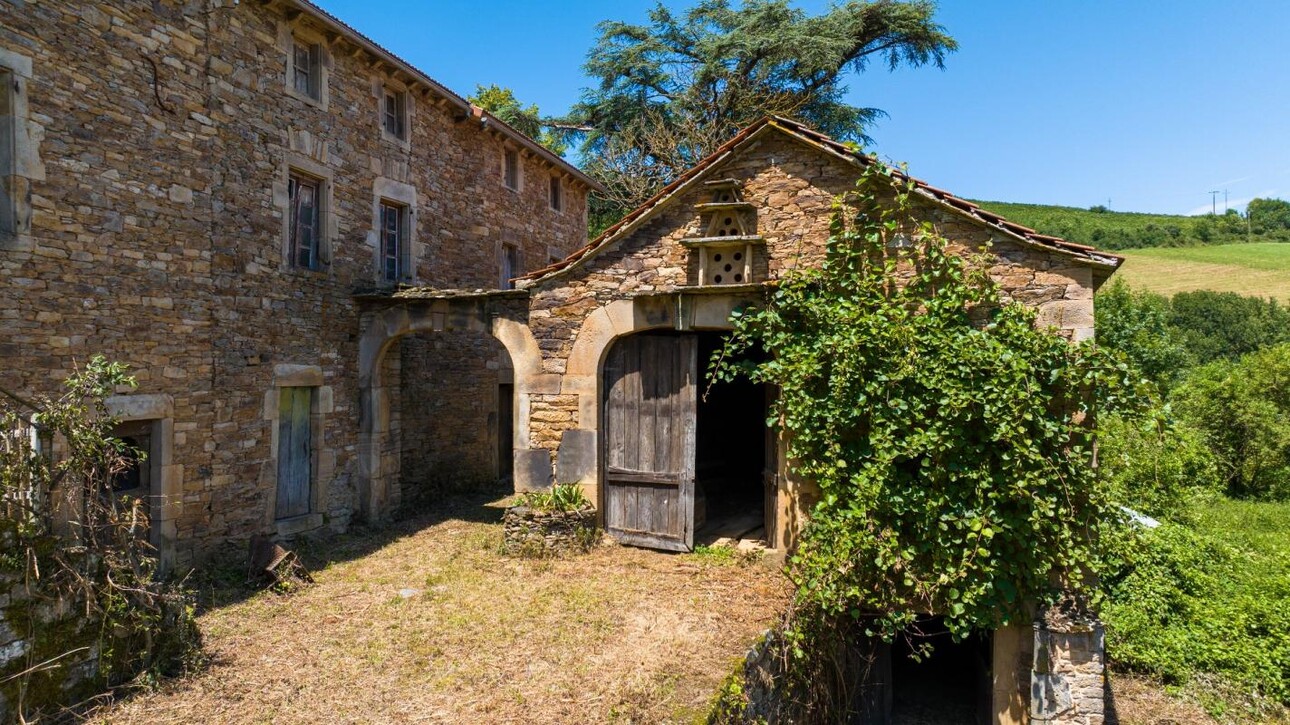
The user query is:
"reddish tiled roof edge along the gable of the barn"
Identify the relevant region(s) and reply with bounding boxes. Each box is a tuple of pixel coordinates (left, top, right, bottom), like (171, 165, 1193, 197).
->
(516, 116, 1124, 280)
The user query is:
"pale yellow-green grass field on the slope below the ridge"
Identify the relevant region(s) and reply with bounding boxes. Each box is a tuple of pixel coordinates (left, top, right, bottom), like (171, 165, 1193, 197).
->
(1116, 243, 1290, 303)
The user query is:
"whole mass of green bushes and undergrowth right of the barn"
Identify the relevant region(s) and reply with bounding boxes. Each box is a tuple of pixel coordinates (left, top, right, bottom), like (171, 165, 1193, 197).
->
(1097, 277, 1290, 720)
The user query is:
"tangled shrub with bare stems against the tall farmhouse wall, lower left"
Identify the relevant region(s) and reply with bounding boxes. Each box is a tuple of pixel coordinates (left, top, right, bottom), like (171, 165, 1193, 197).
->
(0, 357, 200, 717)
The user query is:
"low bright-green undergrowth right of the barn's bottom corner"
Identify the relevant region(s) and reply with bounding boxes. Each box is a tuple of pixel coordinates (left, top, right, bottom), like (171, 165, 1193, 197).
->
(1102, 502, 1290, 703)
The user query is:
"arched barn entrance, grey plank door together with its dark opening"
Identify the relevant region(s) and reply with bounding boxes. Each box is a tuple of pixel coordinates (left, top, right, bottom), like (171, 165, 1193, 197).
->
(601, 330, 775, 551)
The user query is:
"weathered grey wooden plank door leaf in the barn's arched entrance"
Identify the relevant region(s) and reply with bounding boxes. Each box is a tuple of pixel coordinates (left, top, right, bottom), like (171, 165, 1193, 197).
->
(605, 334, 698, 551)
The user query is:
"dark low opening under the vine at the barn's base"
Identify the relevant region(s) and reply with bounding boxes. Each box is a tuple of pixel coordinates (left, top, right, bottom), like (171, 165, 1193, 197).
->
(890, 617, 992, 725)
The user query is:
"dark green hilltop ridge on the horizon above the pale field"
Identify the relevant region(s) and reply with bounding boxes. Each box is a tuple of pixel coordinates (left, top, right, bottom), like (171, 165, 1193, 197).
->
(977, 201, 1290, 249)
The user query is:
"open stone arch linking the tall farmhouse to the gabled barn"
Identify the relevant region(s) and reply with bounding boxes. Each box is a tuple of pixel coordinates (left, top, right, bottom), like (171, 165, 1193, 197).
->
(357, 298, 542, 521)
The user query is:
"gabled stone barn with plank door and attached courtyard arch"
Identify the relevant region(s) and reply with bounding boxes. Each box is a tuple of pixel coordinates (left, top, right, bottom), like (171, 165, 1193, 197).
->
(356, 117, 1121, 722)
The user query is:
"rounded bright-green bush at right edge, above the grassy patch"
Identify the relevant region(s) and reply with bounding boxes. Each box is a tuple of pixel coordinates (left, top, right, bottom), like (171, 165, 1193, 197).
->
(1170, 343, 1290, 501)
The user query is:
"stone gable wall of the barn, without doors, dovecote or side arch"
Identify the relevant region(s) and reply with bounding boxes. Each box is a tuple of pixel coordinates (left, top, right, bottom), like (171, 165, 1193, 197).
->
(516, 132, 1098, 536)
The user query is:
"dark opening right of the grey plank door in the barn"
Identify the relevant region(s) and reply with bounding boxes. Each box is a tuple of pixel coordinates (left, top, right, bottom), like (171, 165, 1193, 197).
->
(694, 332, 775, 546)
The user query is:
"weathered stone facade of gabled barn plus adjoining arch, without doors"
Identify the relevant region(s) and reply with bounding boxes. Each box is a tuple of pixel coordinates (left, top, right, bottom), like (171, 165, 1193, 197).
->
(360, 119, 1120, 544)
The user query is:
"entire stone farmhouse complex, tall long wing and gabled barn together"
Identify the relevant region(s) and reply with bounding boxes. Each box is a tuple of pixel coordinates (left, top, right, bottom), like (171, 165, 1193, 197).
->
(0, 0, 1121, 722)
